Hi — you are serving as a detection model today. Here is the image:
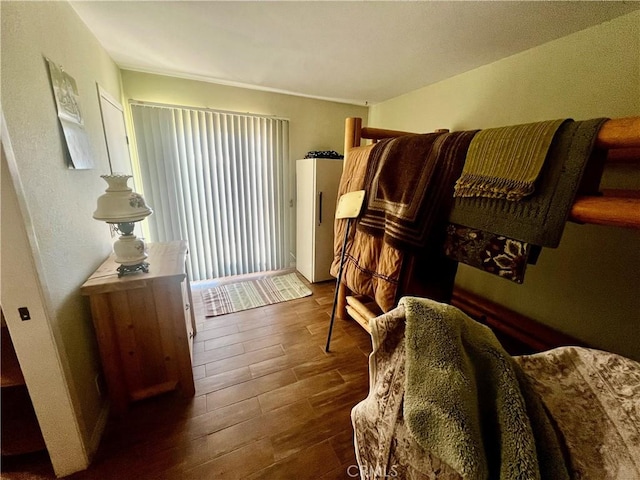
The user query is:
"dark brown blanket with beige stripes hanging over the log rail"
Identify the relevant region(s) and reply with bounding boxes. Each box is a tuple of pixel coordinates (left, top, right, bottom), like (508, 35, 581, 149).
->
(357, 131, 476, 249)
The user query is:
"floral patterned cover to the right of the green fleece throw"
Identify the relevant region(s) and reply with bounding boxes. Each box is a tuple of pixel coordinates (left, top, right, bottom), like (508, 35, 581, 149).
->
(516, 347, 640, 480)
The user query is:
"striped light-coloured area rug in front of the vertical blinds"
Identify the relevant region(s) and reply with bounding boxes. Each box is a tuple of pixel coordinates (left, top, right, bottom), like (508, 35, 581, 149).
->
(202, 273, 311, 317)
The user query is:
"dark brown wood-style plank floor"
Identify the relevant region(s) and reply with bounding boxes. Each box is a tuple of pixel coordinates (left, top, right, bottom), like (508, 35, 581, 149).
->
(2, 276, 371, 480)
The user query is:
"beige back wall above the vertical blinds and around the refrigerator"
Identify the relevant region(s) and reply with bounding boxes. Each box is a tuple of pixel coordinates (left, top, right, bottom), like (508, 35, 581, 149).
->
(122, 70, 367, 264)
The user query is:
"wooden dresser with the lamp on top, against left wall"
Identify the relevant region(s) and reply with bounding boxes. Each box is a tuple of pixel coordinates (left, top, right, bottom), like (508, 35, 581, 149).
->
(81, 241, 196, 414)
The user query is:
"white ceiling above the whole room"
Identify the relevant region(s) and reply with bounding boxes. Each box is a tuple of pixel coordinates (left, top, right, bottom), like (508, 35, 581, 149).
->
(71, 0, 640, 104)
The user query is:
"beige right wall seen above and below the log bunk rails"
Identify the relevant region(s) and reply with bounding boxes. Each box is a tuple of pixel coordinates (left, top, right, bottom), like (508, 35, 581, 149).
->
(369, 12, 640, 360)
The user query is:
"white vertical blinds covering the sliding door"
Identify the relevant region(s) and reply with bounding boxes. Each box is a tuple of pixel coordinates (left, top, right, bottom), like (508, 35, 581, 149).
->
(131, 103, 291, 280)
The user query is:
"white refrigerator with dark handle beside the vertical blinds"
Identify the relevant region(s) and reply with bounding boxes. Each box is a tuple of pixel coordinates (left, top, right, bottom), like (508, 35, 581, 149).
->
(296, 158, 343, 283)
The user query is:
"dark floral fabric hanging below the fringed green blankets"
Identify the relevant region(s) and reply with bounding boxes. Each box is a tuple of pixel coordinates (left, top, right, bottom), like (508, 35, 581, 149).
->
(444, 223, 538, 283)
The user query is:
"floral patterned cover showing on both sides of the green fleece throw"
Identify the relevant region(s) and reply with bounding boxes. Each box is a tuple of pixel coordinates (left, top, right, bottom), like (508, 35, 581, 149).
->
(351, 309, 640, 480)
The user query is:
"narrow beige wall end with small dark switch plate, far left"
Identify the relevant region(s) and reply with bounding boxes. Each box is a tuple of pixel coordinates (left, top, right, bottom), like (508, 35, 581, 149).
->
(0, 141, 88, 475)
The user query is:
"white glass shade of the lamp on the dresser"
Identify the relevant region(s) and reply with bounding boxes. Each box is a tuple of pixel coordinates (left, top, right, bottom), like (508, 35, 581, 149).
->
(93, 175, 153, 223)
